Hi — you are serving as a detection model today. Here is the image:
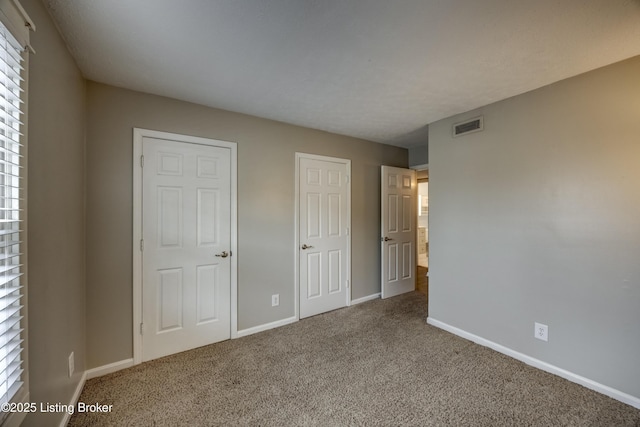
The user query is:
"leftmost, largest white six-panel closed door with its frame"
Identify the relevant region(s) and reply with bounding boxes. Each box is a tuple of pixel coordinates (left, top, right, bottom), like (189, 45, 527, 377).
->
(134, 129, 237, 363)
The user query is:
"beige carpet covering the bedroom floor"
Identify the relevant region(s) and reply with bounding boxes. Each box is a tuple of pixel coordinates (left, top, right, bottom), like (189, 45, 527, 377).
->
(69, 292, 640, 426)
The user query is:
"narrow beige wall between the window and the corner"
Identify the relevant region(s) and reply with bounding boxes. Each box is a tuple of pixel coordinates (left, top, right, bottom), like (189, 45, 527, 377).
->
(22, 0, 86, 426)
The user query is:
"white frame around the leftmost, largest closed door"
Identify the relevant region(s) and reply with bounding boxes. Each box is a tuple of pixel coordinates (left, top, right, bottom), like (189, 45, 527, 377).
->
(132, 128, 238, 365)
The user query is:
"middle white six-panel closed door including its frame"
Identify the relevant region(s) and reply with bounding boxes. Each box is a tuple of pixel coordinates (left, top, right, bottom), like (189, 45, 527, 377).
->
(296, 153, 351, 318)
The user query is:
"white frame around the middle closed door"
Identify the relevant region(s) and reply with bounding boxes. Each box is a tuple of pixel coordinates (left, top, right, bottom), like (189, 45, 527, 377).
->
(293, 152, 352, 320)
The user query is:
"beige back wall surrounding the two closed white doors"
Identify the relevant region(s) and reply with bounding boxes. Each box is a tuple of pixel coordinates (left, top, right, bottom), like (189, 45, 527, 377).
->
(87, 82, 407, 367)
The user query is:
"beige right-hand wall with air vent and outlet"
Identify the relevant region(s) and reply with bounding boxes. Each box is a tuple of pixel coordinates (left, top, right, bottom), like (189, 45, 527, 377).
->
(429, 57, 640, 398)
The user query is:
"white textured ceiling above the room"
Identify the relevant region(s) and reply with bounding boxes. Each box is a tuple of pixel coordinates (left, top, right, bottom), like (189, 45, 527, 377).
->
(42, 0, 640, 147)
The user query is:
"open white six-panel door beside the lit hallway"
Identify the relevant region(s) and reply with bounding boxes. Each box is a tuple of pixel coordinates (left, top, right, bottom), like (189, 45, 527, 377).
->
(380, 166, 417, 298)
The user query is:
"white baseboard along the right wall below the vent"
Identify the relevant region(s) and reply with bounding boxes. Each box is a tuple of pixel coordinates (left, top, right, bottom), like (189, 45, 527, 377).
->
(427, 317, 640, 409)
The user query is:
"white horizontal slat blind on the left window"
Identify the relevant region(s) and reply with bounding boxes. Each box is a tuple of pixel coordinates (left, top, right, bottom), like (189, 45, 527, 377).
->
(0, 19, 24, 403)
